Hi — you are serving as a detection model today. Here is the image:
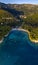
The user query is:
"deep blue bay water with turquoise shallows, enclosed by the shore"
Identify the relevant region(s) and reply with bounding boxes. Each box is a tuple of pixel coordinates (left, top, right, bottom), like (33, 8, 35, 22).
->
(0, 30, 38, 65)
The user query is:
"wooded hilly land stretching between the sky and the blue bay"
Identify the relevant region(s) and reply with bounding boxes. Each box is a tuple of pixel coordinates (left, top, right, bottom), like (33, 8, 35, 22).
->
(0, 3, 38, 39)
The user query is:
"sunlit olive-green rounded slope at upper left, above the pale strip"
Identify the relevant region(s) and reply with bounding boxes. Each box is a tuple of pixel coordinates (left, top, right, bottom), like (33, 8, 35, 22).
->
(0, 9, 13, 22)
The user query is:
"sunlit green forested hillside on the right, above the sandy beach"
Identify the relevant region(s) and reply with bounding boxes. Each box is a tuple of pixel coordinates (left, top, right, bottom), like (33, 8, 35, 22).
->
(21, 13, 38, 40)
